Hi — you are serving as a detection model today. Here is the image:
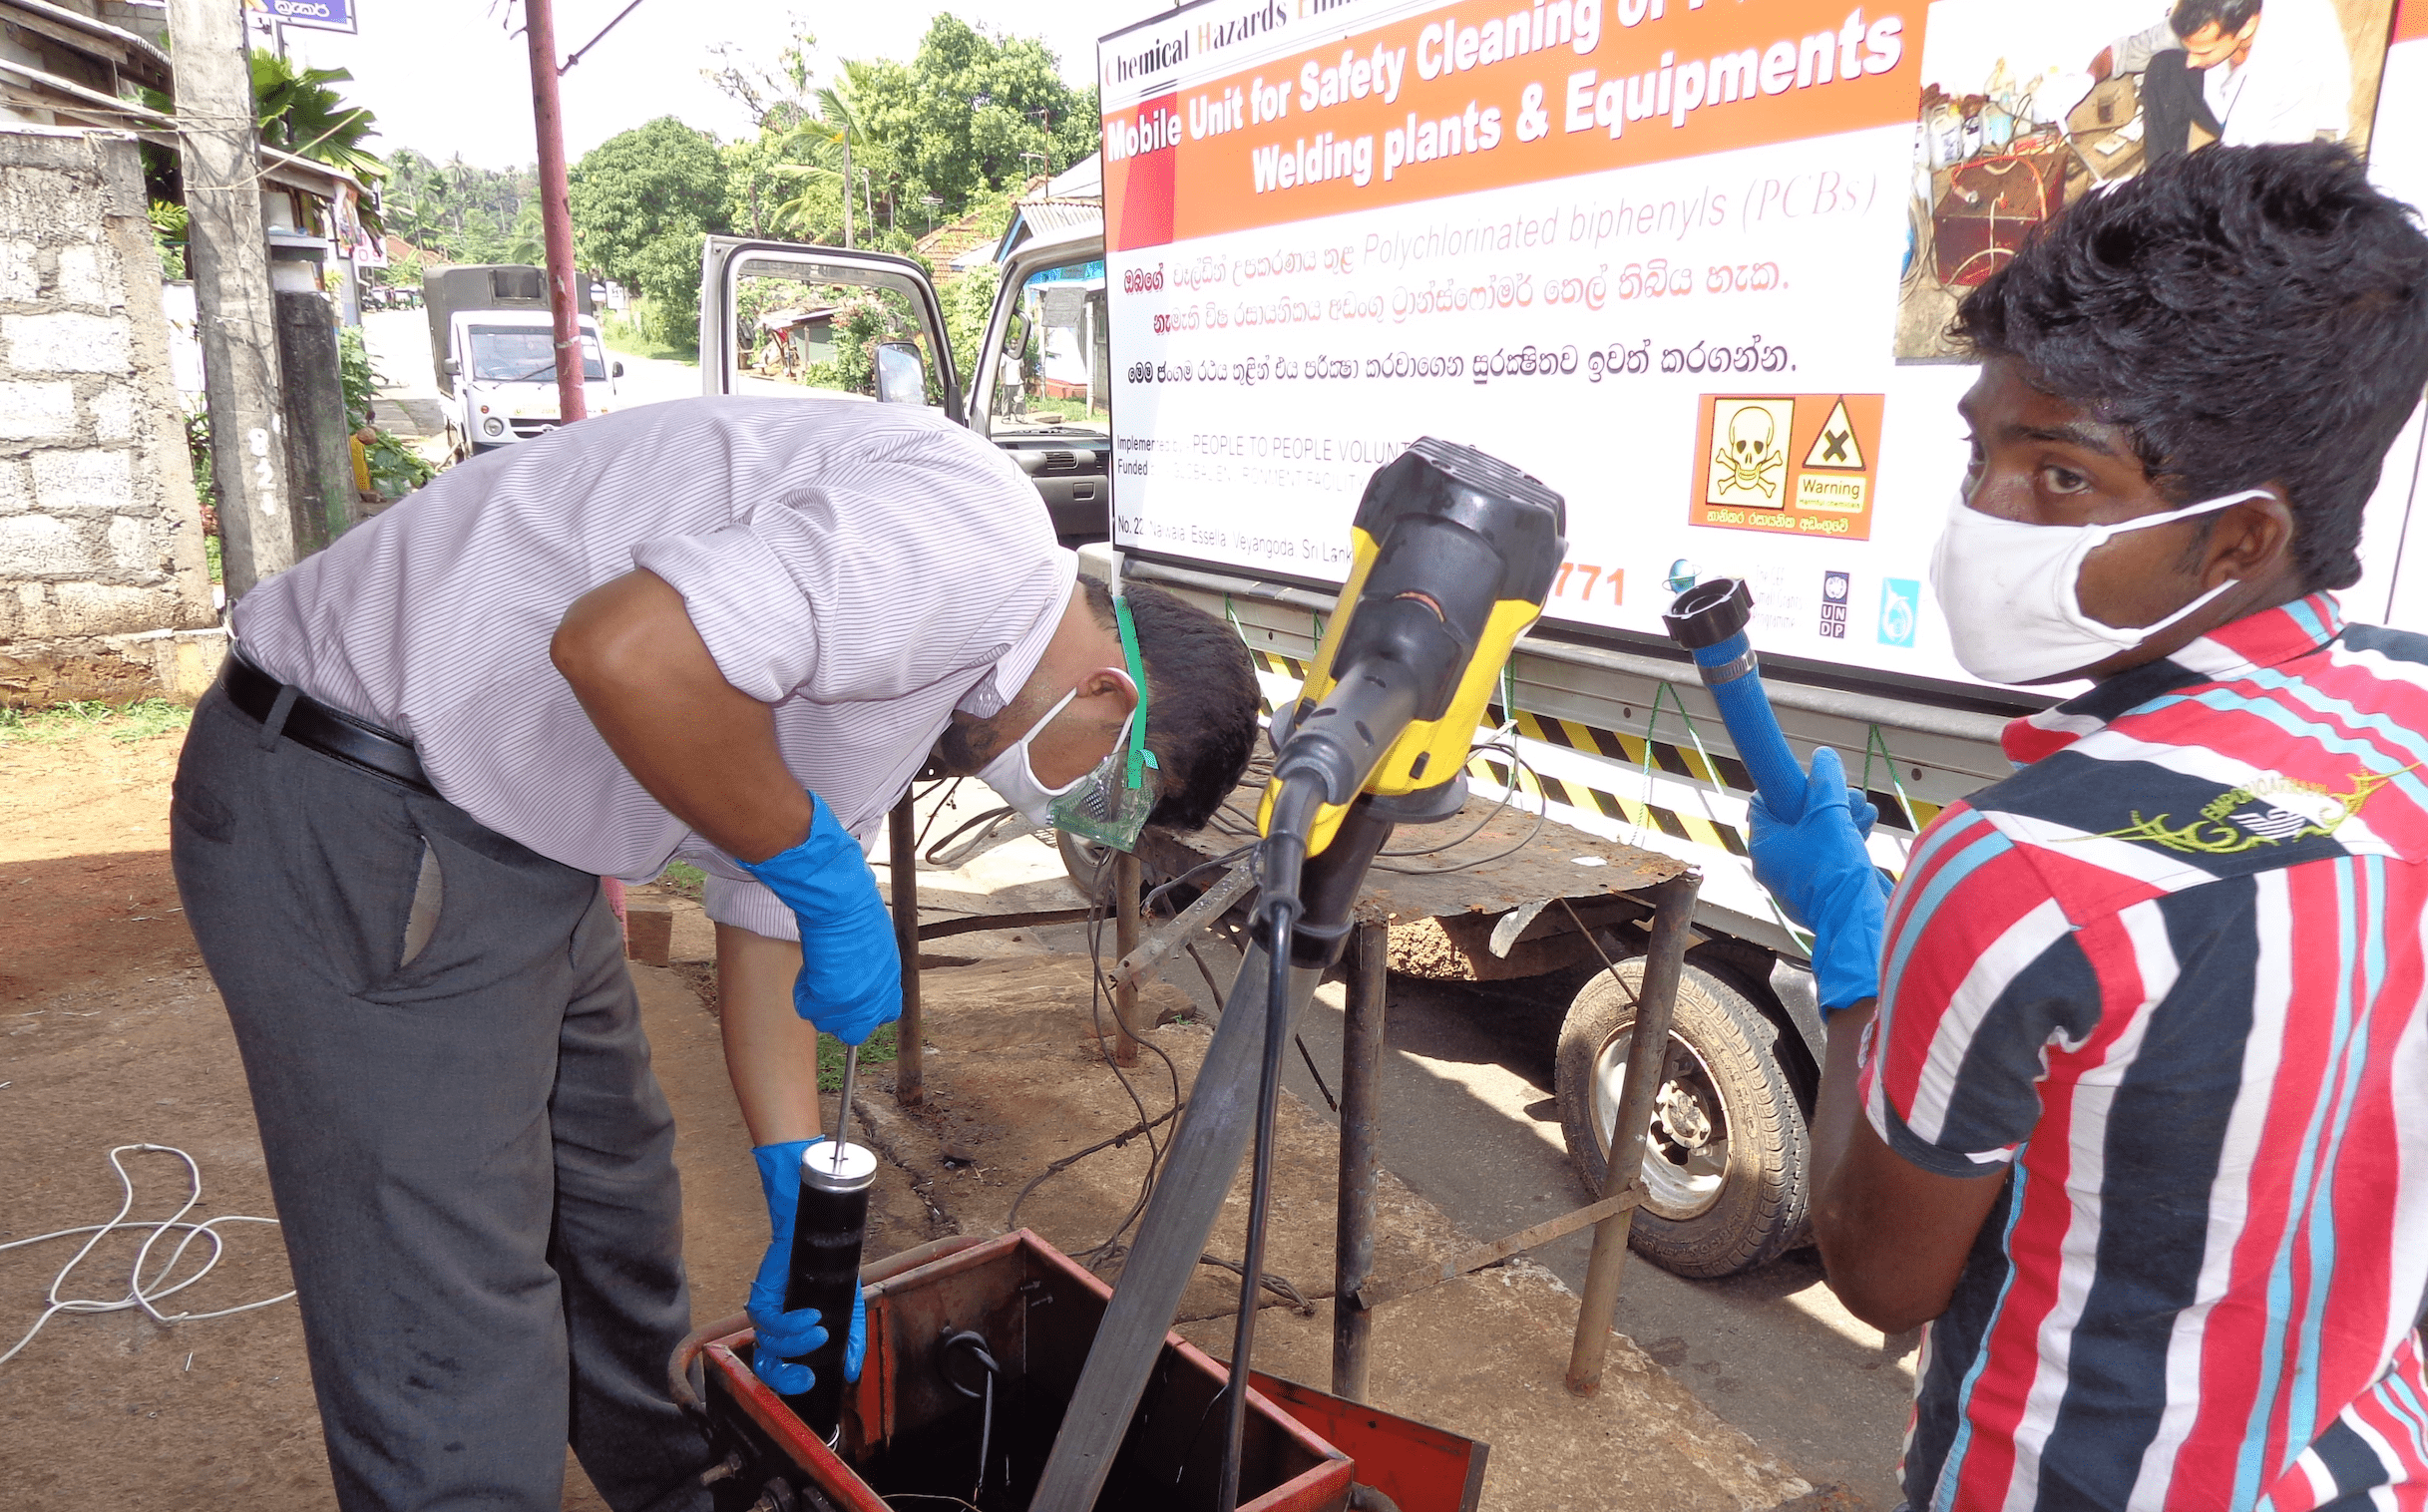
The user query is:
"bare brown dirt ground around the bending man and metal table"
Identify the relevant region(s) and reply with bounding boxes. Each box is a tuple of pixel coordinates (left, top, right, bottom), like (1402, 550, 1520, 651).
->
(0, 735, 1833, 1512)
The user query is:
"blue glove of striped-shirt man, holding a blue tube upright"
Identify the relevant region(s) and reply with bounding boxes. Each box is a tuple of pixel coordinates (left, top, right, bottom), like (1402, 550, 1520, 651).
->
(1748, 745, 1889, 1019)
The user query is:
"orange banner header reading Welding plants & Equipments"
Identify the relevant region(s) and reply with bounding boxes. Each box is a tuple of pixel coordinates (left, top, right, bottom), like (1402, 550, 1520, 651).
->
(1104, 0, 1922, 250)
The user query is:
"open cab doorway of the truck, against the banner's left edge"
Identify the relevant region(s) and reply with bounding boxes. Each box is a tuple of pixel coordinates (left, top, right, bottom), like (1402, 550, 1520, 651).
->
(969, 230, 1112, 544)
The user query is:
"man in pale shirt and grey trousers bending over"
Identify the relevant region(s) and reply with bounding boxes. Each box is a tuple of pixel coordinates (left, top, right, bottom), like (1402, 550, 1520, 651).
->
(173, 398, 1258, 1512)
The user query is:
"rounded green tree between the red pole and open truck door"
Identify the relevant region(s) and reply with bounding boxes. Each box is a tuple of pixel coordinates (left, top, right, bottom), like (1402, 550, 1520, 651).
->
(569, 117, 728, 347)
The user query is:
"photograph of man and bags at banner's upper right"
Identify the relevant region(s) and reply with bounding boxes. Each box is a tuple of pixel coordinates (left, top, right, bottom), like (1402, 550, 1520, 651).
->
(1896, 0, 2394, 362)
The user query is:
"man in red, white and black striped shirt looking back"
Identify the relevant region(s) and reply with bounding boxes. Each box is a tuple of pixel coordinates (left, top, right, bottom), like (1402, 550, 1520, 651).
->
(1753, 146, 2428, 1512)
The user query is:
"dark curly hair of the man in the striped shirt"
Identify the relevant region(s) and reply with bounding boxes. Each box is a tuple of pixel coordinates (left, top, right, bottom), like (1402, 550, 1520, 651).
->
(1950, 144, 2428, 592)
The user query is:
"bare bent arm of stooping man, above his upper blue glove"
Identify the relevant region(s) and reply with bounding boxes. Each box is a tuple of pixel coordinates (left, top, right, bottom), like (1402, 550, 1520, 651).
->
(549, 570, 811, 862)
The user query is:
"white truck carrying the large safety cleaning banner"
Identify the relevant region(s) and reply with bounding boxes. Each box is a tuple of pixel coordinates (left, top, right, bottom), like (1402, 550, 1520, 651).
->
(701, 0, 2428, 1277)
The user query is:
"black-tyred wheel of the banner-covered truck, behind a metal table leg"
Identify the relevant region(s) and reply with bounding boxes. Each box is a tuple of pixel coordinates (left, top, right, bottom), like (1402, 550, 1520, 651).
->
(1554, 956, 1812, 1277)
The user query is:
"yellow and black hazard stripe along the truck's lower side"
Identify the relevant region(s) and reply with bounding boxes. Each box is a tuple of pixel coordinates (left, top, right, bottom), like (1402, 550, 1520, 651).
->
(1248, 648, 1940, 857)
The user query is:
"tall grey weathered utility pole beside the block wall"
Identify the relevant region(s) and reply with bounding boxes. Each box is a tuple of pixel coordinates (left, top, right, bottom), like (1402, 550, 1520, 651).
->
(168, 0, 296, 604)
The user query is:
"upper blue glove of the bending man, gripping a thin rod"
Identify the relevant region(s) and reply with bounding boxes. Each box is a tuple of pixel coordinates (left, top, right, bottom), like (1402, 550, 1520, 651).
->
(740, 794, 903, 1043)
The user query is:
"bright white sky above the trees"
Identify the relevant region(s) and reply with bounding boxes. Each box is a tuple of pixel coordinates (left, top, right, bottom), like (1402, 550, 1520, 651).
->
(260, 0, 1111, 168)
